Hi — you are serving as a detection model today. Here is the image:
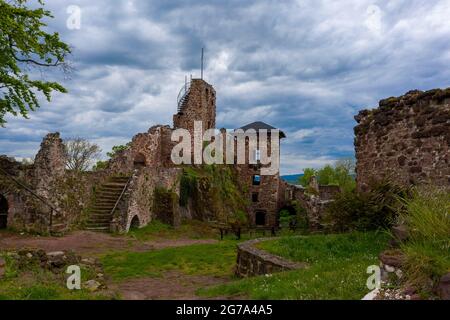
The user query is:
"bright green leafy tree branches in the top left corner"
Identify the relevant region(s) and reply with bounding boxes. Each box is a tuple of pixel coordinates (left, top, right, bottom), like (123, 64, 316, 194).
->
(0, 0, 70, 126)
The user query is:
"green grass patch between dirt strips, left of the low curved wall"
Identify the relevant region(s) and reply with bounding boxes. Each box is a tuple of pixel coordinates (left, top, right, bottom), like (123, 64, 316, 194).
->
(102, 241, 236, 280)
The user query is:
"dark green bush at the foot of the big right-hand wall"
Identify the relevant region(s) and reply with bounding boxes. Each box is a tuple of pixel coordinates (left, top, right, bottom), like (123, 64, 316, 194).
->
(325, 179, 408, 232)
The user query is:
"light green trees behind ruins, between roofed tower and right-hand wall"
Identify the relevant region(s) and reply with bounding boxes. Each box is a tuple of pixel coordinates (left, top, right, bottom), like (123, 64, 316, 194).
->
(299, 159, 356, 191)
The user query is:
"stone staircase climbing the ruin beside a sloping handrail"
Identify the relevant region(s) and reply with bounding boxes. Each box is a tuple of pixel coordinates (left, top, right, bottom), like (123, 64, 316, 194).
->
(86, 177, 130, 232)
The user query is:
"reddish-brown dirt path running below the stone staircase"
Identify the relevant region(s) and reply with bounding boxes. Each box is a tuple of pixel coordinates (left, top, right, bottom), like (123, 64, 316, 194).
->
(0, 231, 217, 255)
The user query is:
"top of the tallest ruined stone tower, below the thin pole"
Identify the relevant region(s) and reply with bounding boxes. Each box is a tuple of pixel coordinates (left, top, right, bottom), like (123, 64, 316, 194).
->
(173, 79, 216, 136)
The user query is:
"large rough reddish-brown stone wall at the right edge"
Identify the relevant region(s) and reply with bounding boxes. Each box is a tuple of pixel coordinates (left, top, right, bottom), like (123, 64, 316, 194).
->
(355, 88, 450, 191)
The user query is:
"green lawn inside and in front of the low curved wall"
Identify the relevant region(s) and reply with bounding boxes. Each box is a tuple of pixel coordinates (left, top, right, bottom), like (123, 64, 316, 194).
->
(198, 232, 389, 299)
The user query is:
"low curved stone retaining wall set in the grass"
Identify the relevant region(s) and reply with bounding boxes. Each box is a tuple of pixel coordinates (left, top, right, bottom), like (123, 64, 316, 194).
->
(235, 239, 306, 277)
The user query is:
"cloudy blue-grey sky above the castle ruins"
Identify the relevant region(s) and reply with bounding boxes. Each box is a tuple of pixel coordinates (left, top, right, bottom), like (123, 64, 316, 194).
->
(0, 0, 450, 174)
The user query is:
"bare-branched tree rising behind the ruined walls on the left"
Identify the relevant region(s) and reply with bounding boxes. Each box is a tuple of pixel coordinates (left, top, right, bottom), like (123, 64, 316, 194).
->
(64, 138, 102, 171)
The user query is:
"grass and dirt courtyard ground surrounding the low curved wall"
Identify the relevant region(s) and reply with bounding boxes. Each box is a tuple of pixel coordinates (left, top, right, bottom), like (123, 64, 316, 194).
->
(0, 224, 386, 299)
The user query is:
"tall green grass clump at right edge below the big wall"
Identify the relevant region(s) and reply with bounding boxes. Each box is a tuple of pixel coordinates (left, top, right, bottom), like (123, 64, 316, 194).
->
(400, 188, 450, 293)
